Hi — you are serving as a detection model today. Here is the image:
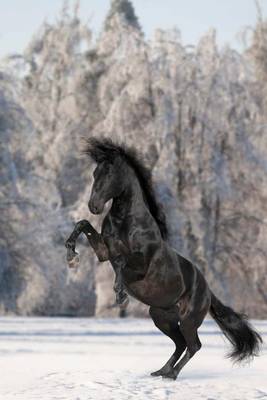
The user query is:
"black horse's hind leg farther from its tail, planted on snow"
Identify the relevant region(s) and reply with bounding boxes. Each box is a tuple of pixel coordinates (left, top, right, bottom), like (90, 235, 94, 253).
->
(149, 307, 186, 376)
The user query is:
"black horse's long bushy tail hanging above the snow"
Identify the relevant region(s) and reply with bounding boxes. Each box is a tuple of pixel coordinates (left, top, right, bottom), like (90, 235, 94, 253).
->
(210, 293, 262, 362)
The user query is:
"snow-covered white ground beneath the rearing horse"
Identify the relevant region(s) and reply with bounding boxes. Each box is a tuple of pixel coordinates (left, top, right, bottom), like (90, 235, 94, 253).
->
(0, 318, 267, 400)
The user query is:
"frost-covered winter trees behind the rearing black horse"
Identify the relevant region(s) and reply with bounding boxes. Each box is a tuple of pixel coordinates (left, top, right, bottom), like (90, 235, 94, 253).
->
(0, 0, 267, 318)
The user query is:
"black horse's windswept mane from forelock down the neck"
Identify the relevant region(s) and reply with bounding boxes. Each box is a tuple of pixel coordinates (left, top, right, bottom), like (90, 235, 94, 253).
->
(84, 137, 168, 239)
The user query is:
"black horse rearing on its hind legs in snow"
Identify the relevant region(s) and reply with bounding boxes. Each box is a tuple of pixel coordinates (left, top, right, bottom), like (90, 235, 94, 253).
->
(66, 138, 262, 379)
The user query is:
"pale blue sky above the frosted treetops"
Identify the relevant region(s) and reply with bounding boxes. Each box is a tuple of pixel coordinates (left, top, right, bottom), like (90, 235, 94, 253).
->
(0, 0, 267, 56)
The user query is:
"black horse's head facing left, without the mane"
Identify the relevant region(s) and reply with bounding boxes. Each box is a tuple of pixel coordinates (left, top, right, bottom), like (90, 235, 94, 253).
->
(88, 157, 126, 214)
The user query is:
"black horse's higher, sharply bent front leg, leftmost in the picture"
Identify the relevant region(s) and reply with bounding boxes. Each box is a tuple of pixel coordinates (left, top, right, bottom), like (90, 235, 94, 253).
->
(65, 219, 109, 268)
